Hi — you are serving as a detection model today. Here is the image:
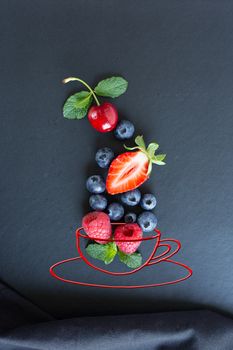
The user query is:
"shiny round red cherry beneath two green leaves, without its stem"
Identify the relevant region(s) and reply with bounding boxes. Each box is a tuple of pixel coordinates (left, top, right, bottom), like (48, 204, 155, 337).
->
(88, 102, 118, 132)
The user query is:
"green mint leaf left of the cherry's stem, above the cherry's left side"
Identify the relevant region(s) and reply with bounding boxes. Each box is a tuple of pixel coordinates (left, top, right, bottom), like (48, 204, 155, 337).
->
(63, 91, 92, 119)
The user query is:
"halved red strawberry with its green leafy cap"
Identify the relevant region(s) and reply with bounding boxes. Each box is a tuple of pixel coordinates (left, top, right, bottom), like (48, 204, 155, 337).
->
(106, 136, 166, 194)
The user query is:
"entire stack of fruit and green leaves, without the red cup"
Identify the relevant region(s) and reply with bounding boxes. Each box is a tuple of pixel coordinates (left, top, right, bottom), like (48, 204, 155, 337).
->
(63, 77, 166, 269)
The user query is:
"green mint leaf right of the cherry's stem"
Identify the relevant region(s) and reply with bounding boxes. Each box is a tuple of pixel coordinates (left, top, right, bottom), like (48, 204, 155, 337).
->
(94, 77, 128, 98)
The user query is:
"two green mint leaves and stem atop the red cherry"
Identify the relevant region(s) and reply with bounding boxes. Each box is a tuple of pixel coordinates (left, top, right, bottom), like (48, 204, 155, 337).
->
(63, 77, 128, 119)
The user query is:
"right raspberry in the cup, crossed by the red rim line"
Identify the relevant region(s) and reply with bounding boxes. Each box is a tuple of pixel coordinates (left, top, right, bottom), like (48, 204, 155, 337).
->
(114, 224, 143, 254)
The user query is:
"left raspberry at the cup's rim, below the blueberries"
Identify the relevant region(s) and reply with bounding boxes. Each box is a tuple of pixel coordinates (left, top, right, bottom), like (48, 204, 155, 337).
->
(82, 211, 112, 244)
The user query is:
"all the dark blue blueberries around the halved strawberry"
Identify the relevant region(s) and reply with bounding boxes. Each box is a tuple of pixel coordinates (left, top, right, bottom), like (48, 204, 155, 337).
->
(86, 129, 157, 232)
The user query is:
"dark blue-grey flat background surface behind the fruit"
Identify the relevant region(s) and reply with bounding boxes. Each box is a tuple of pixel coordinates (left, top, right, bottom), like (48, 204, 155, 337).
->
(0, 0, 233, 317)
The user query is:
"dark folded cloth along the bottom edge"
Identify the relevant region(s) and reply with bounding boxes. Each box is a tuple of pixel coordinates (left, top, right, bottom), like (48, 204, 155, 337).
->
(0, 283, 233, 350)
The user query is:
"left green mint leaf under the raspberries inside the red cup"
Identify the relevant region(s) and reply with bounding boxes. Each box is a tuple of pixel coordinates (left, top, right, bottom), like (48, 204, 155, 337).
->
(86, 242, 117, 265)
